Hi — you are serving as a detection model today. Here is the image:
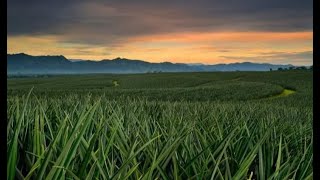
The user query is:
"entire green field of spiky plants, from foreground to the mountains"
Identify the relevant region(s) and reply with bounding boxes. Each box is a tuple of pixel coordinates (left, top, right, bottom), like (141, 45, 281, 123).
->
(7, 72, 313, 179)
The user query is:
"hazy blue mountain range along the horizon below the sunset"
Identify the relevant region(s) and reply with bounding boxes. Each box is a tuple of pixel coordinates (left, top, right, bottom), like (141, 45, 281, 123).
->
(7, 53, 293, 75)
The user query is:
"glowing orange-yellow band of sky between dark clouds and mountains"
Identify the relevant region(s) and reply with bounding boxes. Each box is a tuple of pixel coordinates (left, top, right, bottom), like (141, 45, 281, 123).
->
(7, 32, 313, 64)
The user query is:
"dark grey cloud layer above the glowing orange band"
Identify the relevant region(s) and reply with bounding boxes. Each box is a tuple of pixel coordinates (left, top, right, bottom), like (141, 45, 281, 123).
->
(8, 0, 313, 44)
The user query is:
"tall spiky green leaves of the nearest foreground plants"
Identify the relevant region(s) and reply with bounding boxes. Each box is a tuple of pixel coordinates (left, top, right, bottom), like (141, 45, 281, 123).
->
(7, 96, 313, 179)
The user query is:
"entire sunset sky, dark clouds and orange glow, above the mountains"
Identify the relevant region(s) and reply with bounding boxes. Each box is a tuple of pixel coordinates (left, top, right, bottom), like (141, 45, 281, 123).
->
(7, 0, 313, 65)
